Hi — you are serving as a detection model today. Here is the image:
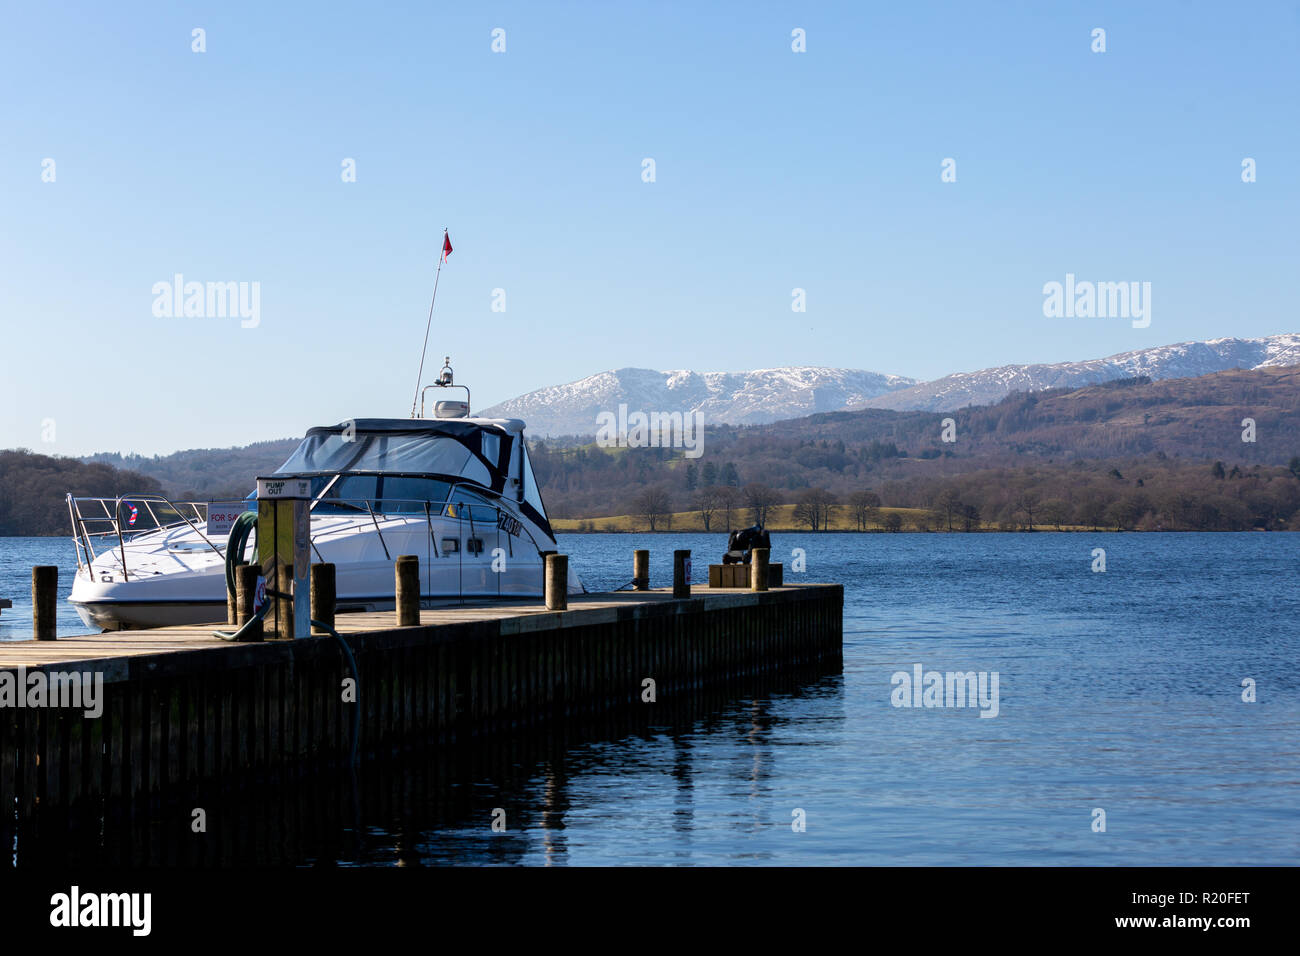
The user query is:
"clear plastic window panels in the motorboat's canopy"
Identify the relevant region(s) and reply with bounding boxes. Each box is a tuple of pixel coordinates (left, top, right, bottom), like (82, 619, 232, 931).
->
(276, 432, 495, 486)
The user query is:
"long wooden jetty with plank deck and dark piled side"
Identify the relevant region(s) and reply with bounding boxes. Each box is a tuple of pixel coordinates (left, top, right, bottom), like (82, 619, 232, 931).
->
(0, 584, 844, 845)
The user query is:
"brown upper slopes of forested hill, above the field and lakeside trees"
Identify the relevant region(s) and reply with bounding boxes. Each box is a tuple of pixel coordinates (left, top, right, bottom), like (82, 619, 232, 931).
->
(533, 367, 1300, 528)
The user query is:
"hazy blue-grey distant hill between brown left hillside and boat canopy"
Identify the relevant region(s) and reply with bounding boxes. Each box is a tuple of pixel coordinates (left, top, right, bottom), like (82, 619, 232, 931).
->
(83, 438, 302, 499)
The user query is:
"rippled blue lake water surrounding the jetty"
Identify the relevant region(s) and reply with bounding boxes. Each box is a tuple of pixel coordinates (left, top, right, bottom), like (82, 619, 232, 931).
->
(0, 533, 1300, 865)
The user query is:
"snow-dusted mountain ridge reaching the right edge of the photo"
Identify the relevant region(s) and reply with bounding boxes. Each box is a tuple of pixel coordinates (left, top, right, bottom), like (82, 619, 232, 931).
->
(858, 333, 1300, 411)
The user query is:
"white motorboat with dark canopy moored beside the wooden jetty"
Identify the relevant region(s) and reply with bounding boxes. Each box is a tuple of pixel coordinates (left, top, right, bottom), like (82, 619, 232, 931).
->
(68, 360, 584, 631)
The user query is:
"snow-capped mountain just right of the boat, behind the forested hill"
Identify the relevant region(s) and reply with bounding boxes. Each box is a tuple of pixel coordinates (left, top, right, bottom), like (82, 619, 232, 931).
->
(475, 367, 917, 436)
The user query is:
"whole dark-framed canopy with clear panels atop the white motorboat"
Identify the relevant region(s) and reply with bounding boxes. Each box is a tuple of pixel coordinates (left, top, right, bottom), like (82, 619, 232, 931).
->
(276, 419, 515, 493)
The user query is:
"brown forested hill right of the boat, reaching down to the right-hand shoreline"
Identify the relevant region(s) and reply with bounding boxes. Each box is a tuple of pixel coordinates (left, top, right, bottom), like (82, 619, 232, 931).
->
(533, 367, 1300, 529)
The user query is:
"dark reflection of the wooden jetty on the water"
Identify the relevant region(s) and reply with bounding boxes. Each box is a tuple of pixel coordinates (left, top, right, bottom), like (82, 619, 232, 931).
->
(17, 667, 841, 868)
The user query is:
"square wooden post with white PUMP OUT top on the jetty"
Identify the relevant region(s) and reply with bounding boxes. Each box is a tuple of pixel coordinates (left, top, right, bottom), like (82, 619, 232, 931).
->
(257, 477, 312, 640)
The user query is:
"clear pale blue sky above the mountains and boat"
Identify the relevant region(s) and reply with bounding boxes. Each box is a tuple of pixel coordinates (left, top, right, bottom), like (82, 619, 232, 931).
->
(0, 0, 1300, 454)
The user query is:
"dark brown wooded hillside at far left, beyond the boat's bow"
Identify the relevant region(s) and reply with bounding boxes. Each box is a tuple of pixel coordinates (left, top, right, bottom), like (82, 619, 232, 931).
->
(0, 449, 163, 536)
